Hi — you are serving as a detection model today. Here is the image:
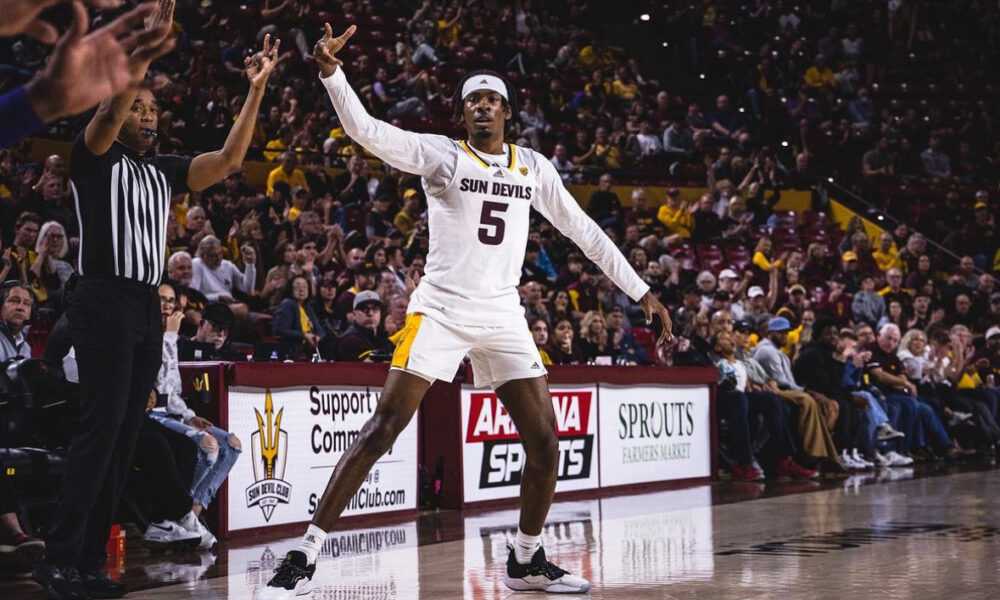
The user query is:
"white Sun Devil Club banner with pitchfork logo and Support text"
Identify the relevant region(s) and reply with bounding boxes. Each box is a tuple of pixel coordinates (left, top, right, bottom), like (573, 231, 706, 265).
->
(227, 386, 417, 531)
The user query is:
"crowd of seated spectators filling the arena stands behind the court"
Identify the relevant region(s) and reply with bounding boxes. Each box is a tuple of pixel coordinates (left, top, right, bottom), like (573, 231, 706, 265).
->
(0, 0, 1000, 576)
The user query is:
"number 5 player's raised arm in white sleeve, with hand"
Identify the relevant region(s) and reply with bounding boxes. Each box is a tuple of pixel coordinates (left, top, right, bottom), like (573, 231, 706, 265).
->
(313, 23, 457, 177)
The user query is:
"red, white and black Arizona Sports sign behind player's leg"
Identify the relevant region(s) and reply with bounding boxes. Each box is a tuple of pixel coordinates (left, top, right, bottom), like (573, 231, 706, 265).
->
(462, 385, 600, 502)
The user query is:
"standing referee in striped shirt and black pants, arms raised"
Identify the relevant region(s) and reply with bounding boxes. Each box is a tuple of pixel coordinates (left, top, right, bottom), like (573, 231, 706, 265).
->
(34, 9, 278, 600)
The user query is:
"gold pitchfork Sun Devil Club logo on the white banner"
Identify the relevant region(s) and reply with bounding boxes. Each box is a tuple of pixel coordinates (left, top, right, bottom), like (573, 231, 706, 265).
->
(246, 390, 292, 521)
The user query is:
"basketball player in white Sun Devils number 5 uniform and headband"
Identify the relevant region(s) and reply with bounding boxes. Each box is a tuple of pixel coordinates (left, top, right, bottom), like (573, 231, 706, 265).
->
(260, 24, 671, 600)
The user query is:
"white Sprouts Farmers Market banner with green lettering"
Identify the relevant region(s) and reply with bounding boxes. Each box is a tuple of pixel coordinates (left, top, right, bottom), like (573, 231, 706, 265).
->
(599, 384, 712, 487)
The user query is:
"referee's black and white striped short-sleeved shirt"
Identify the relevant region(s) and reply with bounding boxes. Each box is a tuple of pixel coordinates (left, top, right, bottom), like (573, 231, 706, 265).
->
(70, 133, 191, 285)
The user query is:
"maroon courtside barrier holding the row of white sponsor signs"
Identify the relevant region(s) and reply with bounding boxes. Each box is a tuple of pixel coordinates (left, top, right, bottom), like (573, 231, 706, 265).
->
(181, 362, 717, 537)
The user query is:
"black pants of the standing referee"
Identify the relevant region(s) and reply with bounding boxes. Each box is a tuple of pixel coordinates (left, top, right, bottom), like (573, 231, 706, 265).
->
(45, 277, 163, 569)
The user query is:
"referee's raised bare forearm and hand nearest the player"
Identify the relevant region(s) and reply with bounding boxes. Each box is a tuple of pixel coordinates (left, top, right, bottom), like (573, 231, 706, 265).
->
(187, 34, 281, 191)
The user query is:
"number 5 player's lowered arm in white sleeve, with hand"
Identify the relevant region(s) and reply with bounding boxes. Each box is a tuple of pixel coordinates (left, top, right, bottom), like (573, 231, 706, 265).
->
(532, 155, 672, 342)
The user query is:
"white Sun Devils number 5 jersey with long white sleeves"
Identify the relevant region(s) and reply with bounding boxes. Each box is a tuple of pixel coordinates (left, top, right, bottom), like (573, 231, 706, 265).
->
(320, 68, 649, 325)
